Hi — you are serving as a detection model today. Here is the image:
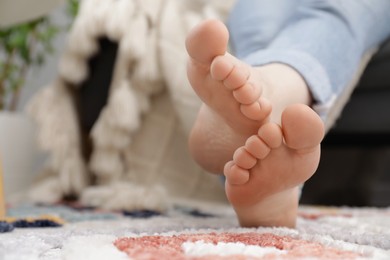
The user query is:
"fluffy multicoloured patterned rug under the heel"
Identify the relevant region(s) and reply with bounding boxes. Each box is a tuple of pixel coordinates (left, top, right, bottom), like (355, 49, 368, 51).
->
(0, 202, 390, 260)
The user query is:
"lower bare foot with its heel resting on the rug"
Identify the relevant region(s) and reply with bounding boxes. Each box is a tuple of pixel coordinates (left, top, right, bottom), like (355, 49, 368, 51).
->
(224, 104, 324, 227)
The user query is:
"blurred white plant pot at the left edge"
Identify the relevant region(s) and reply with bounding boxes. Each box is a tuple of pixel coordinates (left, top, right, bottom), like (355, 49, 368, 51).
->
(0, 112, 43, 200)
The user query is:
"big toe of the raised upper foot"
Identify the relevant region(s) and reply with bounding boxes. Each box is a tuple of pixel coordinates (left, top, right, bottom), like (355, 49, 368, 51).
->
(186, 19, 229, 63)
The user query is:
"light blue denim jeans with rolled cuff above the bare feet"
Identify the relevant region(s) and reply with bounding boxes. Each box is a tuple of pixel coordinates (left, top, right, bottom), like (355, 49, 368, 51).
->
(228, 0, 390, 120)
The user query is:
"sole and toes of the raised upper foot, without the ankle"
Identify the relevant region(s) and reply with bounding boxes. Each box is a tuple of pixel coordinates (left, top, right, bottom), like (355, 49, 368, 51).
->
(186, 20, 271, 173)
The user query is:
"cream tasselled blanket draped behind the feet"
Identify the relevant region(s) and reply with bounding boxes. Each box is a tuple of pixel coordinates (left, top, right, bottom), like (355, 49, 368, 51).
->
(26, 0, 233, 210)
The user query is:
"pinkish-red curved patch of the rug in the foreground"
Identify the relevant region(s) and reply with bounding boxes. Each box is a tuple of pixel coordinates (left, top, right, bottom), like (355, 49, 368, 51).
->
(114, 232, 361, 260)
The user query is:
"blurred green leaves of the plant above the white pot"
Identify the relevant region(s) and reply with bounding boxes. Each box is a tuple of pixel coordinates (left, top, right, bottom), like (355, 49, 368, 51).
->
(0, 0, 79, 110)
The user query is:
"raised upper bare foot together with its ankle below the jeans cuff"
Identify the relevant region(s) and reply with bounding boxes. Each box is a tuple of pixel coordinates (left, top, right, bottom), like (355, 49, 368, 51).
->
(186, 20, 311, 174)
